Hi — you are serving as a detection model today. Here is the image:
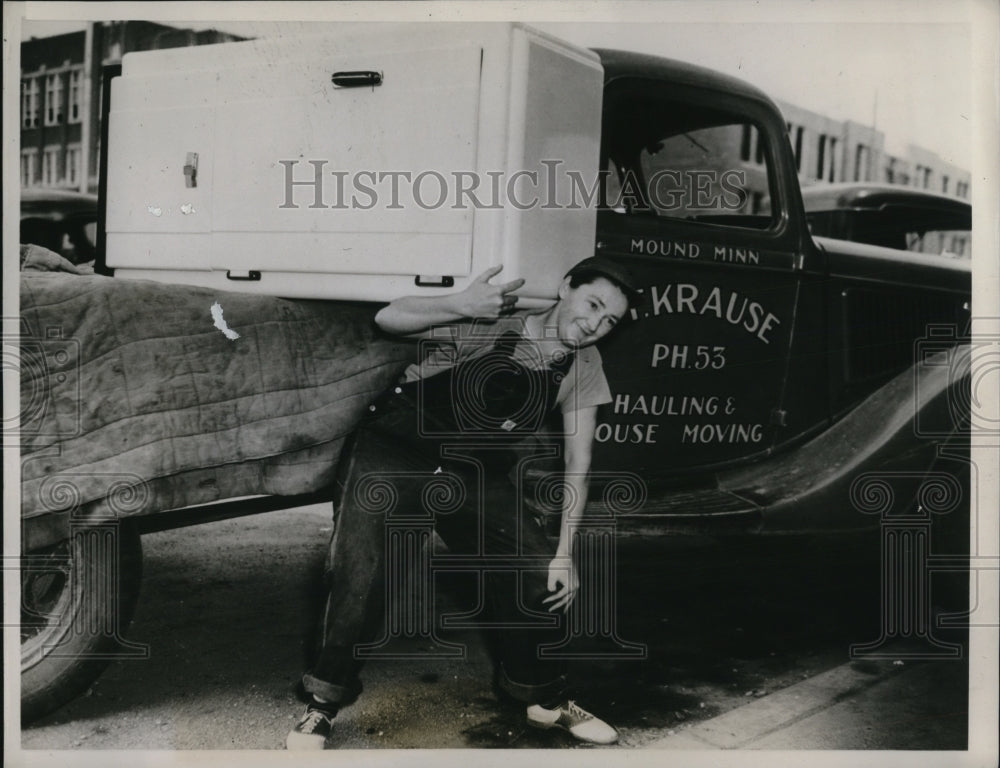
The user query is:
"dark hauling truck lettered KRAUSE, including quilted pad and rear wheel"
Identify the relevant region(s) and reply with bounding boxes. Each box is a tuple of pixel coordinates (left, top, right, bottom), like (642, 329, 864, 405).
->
(21, 50, 971, 720)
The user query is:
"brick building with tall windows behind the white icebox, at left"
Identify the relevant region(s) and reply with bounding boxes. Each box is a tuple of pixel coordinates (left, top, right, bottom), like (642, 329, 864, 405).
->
(20, 21, 243, 192)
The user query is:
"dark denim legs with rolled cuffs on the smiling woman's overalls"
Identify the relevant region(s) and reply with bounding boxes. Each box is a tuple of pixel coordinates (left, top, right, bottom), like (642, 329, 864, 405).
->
(303, 412, 566, 705)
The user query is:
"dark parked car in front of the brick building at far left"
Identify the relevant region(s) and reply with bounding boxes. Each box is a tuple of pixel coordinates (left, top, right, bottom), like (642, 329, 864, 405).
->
(21, 188, 97, 264)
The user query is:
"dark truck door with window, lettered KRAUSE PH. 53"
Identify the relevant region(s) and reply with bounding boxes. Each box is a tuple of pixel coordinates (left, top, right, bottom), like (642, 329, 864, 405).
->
(594, 78, 802, 480)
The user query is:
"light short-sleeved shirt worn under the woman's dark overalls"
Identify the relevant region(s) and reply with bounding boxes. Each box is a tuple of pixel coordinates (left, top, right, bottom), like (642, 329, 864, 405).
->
(403, 312, 611, 413)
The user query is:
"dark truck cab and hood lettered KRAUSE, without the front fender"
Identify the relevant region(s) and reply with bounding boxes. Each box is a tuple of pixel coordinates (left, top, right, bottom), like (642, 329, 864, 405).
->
(576, 50, 971, 530)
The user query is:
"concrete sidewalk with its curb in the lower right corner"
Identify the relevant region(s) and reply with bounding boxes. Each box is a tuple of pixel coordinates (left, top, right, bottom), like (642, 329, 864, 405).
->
(647, 659, 969, 750)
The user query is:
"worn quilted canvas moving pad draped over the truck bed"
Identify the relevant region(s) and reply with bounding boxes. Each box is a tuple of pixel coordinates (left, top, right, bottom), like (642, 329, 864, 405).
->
(20, 272, 416, 517)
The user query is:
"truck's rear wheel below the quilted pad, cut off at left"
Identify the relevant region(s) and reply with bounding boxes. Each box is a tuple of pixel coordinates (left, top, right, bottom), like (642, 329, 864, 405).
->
(21, 523, 142, 723)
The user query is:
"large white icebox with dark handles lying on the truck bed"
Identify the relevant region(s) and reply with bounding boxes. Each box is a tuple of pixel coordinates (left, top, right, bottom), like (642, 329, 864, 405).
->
(106, 24, 603, 305)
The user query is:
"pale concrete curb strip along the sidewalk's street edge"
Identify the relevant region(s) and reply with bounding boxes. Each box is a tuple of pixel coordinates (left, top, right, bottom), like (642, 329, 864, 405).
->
(645, 660, 913, 749)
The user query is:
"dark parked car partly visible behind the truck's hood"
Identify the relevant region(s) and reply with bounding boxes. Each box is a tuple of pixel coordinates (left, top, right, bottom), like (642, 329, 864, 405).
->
(802, 183, 972, 258)
